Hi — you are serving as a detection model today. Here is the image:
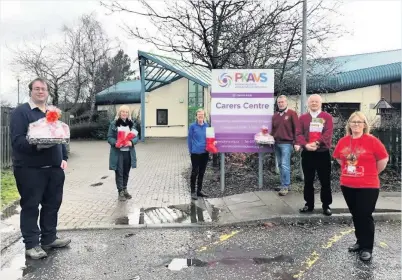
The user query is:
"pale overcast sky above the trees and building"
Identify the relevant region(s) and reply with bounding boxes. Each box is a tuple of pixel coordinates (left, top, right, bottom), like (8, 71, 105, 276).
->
(0, 0, 402, 103)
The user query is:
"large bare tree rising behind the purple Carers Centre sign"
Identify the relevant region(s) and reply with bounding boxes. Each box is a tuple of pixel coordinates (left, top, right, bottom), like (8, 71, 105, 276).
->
(101, 0, 341, 166)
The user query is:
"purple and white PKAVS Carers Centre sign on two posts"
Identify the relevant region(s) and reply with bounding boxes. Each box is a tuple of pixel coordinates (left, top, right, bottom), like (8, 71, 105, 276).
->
(211, 69, 275, 191)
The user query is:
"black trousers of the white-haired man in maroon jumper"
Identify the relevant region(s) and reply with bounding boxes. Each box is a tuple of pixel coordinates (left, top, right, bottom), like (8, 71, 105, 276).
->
(302, 150, 332, 209)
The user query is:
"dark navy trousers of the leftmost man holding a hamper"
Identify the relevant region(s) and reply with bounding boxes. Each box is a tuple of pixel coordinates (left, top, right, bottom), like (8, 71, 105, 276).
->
(14, 167, 65, 249)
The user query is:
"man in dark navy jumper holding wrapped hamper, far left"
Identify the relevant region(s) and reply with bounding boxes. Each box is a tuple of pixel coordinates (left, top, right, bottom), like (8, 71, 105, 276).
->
(10, 78, 71, 259)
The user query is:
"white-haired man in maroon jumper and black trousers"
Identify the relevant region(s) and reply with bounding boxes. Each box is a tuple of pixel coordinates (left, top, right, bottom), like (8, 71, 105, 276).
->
(296, 94, 333, 216)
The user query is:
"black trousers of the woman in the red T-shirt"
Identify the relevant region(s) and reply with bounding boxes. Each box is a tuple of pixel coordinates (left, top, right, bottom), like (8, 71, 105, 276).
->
(341, 186, 380, 252)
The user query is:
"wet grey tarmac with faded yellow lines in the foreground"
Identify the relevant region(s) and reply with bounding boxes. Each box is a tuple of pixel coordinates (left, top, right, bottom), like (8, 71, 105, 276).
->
(0, 223, 401, 280)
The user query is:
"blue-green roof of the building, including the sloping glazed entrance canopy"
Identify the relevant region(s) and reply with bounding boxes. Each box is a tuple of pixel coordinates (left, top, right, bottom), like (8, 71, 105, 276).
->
(96, 50, 402, 105)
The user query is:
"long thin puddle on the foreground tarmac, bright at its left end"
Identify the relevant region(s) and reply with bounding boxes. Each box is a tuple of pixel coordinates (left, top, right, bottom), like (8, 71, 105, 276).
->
(166, 255, 294, 271)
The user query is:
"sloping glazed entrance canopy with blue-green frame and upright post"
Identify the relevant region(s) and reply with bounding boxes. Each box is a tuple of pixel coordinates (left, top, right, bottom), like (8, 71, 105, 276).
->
(138, 51, 211, 141)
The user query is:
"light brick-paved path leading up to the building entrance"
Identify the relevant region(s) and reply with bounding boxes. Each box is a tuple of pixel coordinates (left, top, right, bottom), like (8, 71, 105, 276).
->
(59, 139, 190, 228)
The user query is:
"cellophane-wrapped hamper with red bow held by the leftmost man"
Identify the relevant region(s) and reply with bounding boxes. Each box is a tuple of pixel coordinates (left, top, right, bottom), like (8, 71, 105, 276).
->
(27, 106, 70, 145)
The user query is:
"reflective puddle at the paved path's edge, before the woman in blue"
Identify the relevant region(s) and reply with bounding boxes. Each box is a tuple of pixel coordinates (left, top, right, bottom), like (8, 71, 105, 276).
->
(115, 202, 220, 225)
